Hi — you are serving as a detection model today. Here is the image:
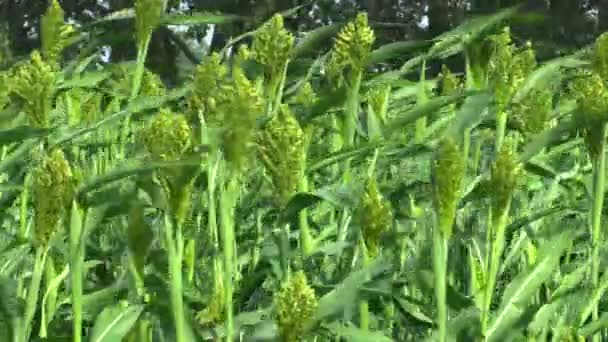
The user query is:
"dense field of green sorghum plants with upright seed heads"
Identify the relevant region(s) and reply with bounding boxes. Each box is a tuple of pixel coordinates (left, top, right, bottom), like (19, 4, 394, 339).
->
(0, 0, 608, 342)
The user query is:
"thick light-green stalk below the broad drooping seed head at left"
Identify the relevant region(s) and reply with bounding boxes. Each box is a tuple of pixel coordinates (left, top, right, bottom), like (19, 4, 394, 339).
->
(164, 215, 186, 342)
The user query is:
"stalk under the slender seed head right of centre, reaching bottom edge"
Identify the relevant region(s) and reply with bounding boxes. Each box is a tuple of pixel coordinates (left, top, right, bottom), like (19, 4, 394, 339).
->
(433, 226, 448, 342)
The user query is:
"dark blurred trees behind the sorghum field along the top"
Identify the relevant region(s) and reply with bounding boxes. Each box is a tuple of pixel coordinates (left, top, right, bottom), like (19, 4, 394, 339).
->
(0, 0, 608, 83)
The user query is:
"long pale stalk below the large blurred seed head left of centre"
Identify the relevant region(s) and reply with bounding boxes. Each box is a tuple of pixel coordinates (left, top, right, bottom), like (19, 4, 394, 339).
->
(220, 177, 239, 342)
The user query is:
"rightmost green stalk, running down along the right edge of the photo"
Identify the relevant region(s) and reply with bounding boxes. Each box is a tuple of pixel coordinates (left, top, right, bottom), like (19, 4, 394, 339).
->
(591, 123, 606, 341)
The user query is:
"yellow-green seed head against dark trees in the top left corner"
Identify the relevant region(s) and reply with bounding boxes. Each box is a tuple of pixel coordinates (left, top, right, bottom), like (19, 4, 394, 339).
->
(40, 0, 74, 65)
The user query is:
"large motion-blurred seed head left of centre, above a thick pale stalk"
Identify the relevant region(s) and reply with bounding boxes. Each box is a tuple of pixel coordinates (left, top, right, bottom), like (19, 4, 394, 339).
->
(218, 68, 263, 171)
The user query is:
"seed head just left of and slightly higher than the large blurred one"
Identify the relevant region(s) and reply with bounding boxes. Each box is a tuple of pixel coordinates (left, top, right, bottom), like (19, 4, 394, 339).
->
(188, 53, 228, 121)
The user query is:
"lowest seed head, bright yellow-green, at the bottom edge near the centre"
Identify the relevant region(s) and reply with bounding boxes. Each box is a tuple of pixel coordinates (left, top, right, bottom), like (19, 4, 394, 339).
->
(275, 271, 318, 342)
